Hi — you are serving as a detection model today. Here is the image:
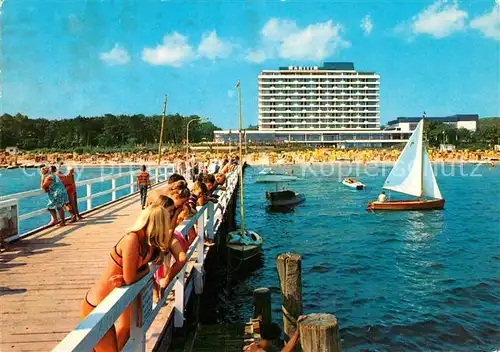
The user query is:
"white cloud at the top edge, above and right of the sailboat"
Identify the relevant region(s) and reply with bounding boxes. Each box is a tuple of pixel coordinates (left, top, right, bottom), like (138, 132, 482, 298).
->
(396, 0, 468, 39)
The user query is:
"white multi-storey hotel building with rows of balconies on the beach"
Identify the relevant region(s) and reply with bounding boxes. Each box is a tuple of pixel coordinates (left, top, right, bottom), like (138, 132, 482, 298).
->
(215, 62, 410, 148)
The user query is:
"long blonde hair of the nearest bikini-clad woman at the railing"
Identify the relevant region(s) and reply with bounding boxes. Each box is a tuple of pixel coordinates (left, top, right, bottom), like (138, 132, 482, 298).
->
(129, 204, 172, 252)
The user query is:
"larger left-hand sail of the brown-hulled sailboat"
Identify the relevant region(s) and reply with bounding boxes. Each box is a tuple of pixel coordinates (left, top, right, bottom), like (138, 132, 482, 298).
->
(383, 121, 424, 197)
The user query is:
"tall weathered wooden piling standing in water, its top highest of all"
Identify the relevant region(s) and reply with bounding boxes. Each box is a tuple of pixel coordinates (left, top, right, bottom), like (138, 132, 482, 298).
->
(276, 253, 302, 341)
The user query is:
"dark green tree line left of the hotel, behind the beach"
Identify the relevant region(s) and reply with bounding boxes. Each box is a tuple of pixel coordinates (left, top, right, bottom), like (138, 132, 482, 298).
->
(0, 113, 219, 150)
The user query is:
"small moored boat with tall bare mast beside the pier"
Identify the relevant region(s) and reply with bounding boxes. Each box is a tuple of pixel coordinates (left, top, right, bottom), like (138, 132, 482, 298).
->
(226, 81, 264, 264)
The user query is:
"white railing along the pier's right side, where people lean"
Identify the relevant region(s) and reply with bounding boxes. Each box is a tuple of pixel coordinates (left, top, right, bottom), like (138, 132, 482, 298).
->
(53, 171, 238, 352)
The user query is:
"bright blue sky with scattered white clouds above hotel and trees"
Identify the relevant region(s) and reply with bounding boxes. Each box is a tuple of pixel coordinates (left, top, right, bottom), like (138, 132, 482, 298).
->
(0, 0, 500, 129)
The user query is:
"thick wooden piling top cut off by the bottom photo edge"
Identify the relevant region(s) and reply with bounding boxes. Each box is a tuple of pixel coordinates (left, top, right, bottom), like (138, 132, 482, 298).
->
(299, 313, 340, 352)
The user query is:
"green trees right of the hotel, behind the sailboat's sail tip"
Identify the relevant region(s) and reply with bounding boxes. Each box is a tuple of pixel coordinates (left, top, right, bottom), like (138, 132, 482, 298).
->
(424, 118, 500, 149)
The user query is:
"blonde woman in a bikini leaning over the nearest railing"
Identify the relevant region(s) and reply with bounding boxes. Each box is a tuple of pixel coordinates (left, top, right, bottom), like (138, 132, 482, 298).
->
(81, 201, 186, 352)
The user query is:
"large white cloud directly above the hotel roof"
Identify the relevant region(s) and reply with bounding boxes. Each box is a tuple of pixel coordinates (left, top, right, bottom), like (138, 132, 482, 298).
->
(247, 18, 350, 63)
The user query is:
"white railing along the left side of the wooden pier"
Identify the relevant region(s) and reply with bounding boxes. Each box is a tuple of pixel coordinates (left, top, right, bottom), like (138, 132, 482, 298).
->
(0, 165, 174, 242)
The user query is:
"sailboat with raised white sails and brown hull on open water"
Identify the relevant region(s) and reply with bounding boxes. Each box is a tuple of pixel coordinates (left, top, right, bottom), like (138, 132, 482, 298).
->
(367, 118, 444, 210)
